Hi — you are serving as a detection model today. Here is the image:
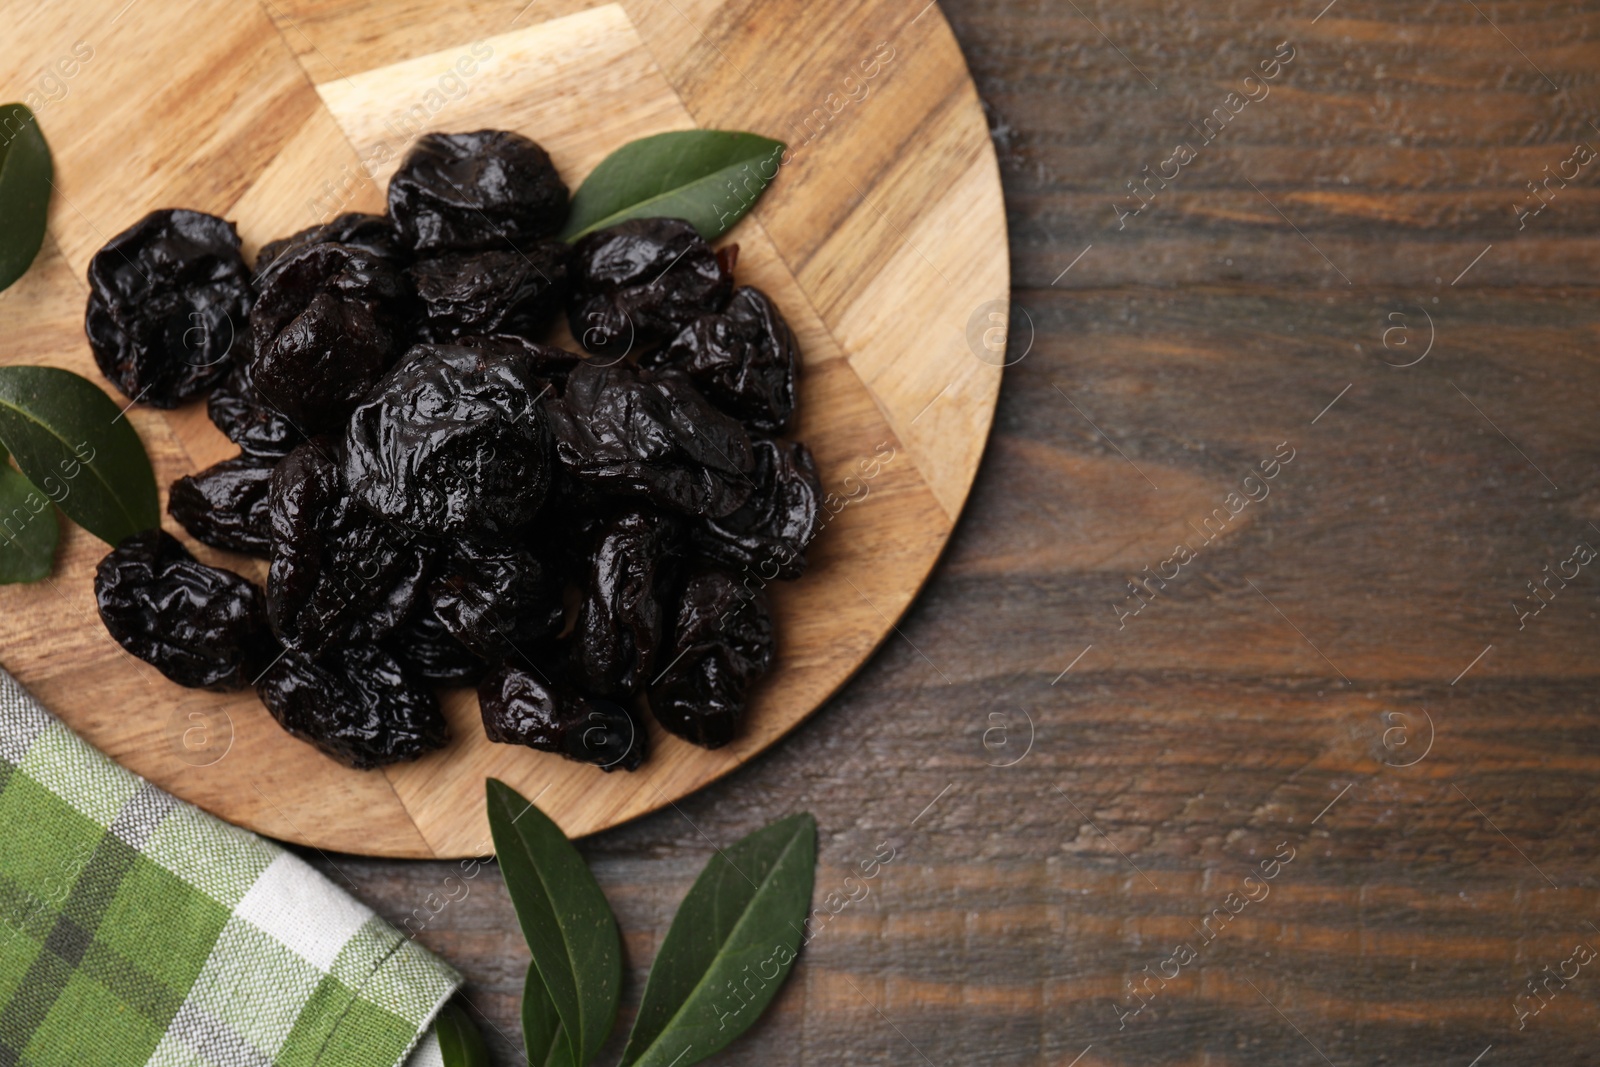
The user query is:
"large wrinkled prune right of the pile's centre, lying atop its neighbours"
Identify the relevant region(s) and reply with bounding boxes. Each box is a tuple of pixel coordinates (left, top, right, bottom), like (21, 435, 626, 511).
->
(546, 363, 754, 517)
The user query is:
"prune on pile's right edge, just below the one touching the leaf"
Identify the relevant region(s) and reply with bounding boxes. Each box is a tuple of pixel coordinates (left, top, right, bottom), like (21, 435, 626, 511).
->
(646, 286, 800, 434)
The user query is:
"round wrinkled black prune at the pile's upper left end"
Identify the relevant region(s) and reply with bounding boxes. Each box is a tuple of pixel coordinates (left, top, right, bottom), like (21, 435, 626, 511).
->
(83, 210, 253, 408)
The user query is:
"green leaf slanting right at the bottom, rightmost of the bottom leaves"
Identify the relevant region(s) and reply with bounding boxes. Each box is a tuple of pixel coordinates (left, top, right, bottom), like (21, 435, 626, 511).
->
(622, 813, 816, 1067)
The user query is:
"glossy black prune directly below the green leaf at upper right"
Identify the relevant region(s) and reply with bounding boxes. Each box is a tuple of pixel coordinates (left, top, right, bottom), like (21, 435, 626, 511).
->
(566, 219, 733, 357)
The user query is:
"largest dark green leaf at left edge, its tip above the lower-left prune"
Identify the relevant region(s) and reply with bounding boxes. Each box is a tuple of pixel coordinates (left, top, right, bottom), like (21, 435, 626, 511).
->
(0, 366, 162, 545)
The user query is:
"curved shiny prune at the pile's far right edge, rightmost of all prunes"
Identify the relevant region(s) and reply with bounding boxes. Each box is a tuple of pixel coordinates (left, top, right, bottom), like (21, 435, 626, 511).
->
(691, 437, 822, 581)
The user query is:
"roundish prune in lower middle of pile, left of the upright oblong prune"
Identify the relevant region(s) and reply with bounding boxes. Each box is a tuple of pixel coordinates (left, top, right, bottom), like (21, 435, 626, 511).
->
(429, 549, 565, 661)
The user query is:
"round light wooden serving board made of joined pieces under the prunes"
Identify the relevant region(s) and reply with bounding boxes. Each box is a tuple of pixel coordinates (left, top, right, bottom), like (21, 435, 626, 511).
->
(0, 0, 1010, 857)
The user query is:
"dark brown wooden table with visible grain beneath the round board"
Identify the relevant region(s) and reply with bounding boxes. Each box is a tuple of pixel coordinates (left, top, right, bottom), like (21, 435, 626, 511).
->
(312, 0, 1600, 1067)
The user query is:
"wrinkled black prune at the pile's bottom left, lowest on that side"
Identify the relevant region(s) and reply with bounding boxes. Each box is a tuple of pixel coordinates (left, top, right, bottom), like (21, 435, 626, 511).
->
(256, 645, 450, 771)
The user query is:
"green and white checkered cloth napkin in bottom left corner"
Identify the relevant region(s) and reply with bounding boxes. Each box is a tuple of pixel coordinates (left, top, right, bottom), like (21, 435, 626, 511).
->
(0, 670, 461, 1067)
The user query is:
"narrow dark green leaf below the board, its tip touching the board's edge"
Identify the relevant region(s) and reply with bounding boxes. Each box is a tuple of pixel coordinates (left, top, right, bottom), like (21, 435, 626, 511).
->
(486, 777, 622, 1067)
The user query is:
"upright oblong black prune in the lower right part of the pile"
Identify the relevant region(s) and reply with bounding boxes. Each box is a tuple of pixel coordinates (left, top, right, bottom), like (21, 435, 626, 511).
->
(571, 509, 682, 696)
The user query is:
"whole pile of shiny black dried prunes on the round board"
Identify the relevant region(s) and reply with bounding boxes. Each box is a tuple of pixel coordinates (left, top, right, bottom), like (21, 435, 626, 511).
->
(85, 130, 821, 771)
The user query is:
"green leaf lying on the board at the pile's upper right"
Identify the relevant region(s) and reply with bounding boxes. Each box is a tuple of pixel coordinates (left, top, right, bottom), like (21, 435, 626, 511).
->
(562, 130, 786, 242)
